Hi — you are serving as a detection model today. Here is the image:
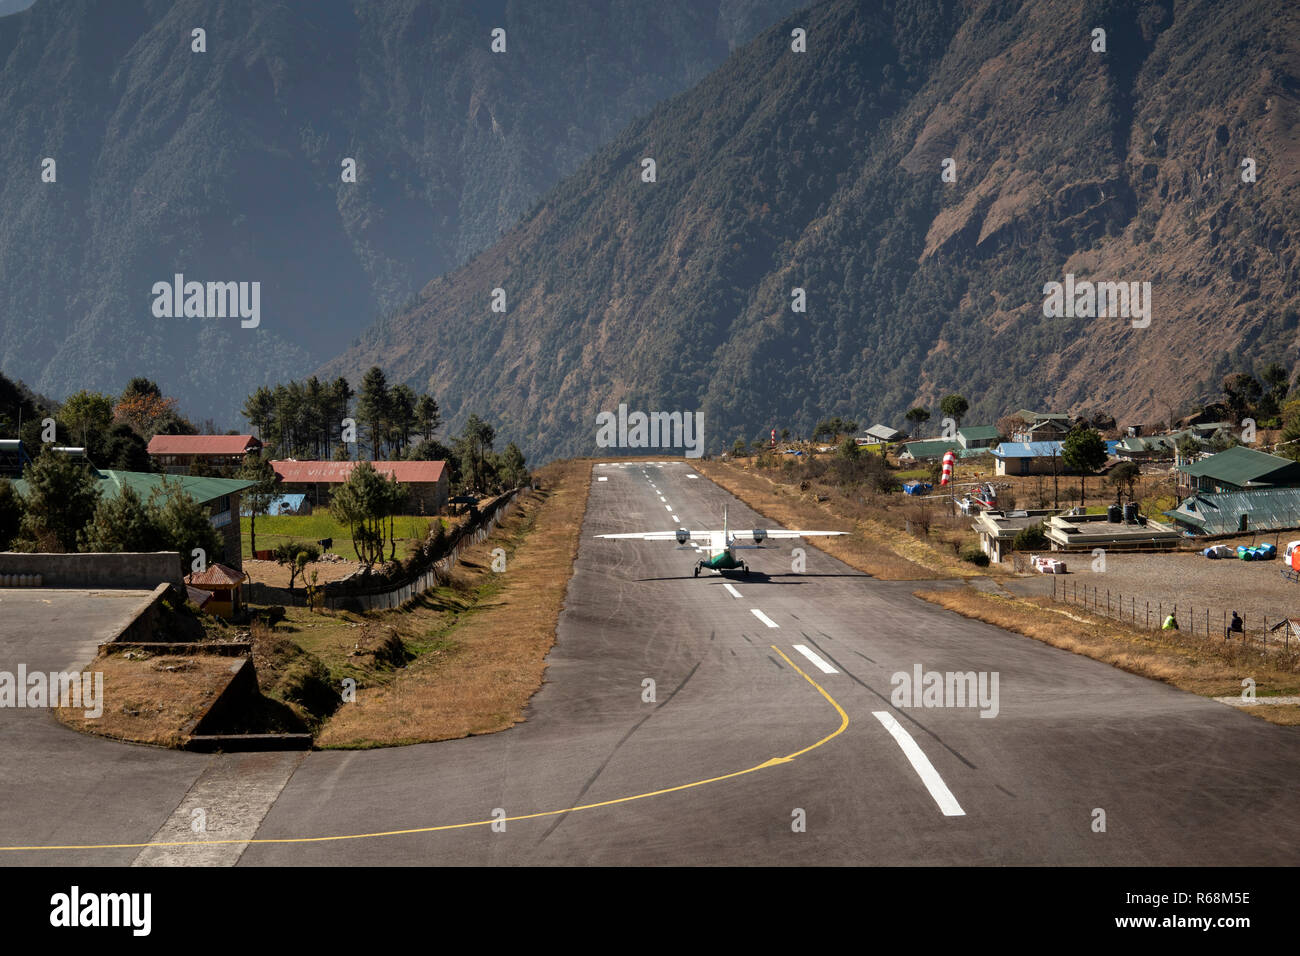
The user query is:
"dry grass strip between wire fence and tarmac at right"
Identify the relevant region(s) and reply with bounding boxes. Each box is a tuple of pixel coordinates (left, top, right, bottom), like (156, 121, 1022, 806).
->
(915, 587, 1300, 724)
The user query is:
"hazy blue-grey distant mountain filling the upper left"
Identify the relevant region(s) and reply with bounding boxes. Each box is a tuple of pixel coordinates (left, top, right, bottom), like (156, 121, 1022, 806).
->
(0, 0, 797, 425)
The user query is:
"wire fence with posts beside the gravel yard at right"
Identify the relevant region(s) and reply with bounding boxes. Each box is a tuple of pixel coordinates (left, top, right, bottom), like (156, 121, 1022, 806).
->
(1052, 575, 1300, 653)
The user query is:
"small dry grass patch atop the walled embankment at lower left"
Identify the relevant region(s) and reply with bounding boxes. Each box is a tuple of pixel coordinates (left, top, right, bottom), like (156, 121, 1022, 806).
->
(55, 652, 239, 747)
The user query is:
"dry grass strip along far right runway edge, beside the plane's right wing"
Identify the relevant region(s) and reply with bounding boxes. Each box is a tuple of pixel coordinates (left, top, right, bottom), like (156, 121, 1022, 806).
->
(696, 460, 984, 581)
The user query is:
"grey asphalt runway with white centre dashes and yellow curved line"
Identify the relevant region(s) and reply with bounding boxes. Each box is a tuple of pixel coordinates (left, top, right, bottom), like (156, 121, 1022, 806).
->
(0, 460, 1300, 866)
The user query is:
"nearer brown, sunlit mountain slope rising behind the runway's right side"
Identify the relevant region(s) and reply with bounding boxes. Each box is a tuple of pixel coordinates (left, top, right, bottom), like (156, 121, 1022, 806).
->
(321, 0, 1300, 458)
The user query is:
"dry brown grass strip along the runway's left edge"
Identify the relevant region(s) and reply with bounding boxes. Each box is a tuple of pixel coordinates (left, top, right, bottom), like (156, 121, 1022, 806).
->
(317, 462, 590, 748)
